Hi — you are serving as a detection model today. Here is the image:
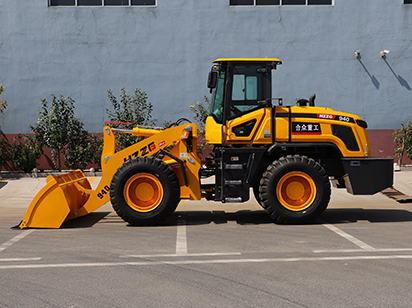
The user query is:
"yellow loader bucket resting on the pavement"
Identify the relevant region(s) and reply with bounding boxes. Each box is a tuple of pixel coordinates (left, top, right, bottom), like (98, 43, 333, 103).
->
(19, 170, 92, 228)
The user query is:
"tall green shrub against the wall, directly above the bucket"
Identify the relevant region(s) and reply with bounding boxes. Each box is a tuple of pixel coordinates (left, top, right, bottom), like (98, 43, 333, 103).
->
(30, 95, 87, 171)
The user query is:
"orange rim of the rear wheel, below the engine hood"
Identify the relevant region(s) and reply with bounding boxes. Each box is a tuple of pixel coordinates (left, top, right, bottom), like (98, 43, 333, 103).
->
(276, 171, 316, 212)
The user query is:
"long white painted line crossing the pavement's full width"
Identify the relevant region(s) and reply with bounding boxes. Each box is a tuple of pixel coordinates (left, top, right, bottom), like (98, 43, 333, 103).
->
(0, 255, 412, 270)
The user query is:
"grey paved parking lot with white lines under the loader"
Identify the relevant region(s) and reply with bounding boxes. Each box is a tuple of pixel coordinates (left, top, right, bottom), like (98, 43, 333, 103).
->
(0, 168, 412, 307)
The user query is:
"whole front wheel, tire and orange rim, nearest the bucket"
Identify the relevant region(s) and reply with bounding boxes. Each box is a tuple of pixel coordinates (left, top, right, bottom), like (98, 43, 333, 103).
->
(110, 156, 180, 225)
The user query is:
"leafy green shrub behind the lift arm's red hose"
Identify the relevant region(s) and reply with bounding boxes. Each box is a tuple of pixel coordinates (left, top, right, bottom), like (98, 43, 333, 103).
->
(106, 88, 156, 149)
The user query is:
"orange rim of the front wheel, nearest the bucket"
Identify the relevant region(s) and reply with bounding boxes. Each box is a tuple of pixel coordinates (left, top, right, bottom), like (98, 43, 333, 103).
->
(124, 173, 164, 212)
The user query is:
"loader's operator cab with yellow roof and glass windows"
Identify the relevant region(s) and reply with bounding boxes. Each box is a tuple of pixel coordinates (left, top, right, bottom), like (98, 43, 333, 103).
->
(206, 58, 282, 144)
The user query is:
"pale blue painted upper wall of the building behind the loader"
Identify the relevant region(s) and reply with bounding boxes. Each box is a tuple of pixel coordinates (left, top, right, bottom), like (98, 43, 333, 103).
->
(0, 0, 412, 133)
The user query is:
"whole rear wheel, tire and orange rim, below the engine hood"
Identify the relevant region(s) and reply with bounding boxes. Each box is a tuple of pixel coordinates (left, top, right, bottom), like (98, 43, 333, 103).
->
(259, 155, 331, 223)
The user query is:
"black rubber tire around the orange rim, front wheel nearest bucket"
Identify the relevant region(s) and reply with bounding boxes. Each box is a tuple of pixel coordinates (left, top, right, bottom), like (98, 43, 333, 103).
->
(110, 156, 180, 225)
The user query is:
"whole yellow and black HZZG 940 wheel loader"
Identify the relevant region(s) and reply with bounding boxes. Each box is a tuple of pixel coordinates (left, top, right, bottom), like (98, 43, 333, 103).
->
(19, 58, 393, 228)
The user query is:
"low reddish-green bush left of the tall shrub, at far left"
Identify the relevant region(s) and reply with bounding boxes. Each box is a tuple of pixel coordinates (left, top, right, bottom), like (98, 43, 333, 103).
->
(10, 134, 43, 172)
